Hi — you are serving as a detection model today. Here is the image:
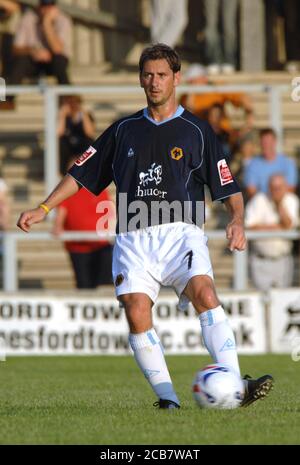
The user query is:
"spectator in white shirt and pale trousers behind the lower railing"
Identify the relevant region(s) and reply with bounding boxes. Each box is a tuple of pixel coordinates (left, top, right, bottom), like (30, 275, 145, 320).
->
(245, 174, 299, 291)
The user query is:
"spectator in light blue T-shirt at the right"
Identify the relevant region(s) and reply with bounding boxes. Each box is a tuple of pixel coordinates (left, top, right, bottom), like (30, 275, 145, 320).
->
(244, 128, 298, 197)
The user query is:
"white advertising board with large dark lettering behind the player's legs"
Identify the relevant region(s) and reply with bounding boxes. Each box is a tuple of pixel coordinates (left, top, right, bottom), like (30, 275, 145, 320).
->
(0, 293, 266, 355)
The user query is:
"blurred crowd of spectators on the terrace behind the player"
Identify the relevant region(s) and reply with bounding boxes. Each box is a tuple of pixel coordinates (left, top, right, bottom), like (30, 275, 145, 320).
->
(0, 0, 300, 290)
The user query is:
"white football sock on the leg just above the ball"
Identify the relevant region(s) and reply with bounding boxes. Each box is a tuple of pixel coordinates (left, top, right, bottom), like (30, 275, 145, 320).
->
(199, 305, 240, 374)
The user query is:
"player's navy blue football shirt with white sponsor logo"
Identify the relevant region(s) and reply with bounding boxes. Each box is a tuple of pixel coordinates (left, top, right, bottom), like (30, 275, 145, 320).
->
(69, 106, 240, 232)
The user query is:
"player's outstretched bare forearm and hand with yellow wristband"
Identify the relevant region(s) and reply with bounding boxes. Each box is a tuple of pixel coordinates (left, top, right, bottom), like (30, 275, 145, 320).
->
(17, 175, 80, 232)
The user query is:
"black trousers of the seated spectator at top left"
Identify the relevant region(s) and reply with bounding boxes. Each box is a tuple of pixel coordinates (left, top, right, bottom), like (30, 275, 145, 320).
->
(9, 55, 70, 85)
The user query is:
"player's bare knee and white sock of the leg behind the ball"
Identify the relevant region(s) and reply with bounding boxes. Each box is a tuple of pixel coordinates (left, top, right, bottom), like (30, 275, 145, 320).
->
(184, 275, 240, 373)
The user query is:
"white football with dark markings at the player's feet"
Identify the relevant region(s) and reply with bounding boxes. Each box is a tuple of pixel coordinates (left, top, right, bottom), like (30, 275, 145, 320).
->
(193, 363, 244, 409)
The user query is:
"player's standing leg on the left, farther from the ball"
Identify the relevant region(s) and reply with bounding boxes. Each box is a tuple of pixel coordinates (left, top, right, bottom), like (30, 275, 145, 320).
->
(118, 292, 179, 408)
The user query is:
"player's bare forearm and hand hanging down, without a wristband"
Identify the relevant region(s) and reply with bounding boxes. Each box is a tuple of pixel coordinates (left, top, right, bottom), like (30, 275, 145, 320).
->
(224, 192, 246, 252)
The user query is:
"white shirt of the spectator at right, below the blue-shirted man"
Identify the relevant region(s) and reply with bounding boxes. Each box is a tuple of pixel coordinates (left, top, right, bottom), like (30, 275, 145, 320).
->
(245, 192, 299, 258)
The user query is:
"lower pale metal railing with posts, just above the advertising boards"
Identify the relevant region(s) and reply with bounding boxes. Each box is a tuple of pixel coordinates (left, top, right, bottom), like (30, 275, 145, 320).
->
(2, 230, 300, 292)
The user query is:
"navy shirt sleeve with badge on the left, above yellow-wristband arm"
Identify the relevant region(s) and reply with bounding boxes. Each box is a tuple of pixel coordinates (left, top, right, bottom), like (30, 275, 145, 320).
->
(68, 125, 115, 195)
